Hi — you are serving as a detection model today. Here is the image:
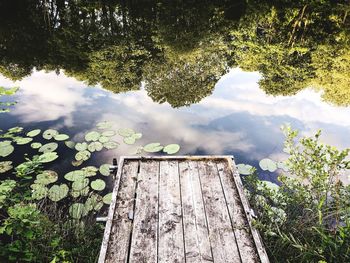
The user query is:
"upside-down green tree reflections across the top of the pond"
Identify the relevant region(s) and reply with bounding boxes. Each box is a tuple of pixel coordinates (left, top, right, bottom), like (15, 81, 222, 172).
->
(0, 0, 350, 107)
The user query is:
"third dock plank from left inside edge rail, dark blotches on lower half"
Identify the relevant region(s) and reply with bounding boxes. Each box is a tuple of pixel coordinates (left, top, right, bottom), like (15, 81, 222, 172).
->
(158, 161, 185, 263)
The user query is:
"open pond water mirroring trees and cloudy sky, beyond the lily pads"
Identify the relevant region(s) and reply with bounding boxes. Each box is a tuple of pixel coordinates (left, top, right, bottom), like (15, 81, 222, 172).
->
(0, 0, 350, 185)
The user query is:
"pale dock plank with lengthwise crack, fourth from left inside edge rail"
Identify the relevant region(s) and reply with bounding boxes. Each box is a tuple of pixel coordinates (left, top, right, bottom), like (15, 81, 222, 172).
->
(179, 161, 213, 263)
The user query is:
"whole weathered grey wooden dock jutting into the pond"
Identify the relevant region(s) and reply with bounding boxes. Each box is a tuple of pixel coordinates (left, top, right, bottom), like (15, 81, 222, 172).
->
(99, 156, 269, 263)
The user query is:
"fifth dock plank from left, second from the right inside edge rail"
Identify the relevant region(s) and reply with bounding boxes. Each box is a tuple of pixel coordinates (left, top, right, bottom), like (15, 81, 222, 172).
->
(198, 161, 241, 263)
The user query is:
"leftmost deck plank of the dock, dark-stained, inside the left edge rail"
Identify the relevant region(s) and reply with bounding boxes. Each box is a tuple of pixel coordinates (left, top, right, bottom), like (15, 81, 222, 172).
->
(105, 161, 139, 263)
